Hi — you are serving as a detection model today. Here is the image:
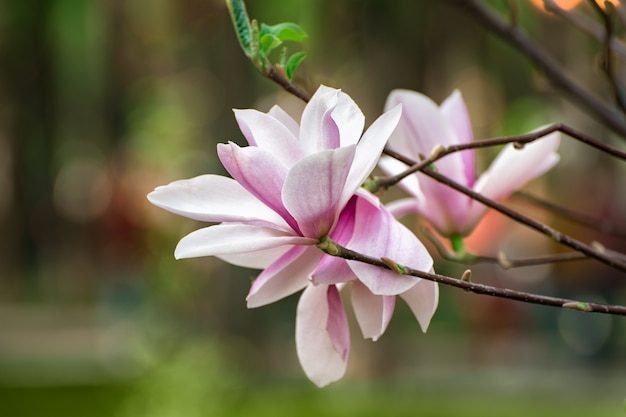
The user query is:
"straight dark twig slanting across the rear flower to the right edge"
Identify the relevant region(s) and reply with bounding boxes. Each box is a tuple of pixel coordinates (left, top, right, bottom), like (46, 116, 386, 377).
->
(384, 149, 626, 272)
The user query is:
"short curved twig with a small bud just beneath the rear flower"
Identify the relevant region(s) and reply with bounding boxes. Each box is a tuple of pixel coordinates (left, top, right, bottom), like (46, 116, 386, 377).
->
(420, 227, 589, 269)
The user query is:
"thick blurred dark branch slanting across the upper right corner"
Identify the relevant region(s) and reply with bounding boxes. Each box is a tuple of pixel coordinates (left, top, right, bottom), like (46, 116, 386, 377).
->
(449, 0, 626, 138)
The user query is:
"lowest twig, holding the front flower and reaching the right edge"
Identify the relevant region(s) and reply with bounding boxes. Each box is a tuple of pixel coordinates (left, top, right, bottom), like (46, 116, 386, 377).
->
(316, 242, 626, 316)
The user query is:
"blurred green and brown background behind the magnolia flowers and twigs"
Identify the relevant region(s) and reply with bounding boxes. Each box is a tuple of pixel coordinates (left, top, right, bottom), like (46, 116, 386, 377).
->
(0, 0, 626, 417)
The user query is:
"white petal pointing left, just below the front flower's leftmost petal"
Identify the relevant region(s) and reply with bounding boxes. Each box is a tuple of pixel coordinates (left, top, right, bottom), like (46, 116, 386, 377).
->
(174, 223, 317, 259)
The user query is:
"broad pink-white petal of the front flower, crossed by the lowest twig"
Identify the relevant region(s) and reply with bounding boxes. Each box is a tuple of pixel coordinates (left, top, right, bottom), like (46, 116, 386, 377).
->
(348, 197, 433, 295)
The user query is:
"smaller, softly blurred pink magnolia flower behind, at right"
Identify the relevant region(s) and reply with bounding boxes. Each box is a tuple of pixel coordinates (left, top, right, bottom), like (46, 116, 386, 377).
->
(380, 90, 560, 237)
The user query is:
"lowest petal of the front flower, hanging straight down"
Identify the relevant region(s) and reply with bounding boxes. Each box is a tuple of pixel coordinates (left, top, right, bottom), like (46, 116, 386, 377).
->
(296, 285, 350, 387)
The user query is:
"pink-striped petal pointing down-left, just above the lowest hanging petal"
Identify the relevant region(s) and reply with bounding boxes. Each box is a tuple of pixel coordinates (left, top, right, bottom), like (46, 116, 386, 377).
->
(246, 246, 324, 308)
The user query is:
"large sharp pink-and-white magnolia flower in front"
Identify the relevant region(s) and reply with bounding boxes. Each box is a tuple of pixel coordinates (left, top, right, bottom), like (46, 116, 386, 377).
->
(148, 86, 438, 386)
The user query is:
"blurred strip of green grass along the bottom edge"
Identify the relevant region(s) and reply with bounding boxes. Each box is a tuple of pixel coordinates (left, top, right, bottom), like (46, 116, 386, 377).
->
(0, 381, 623, 417)
